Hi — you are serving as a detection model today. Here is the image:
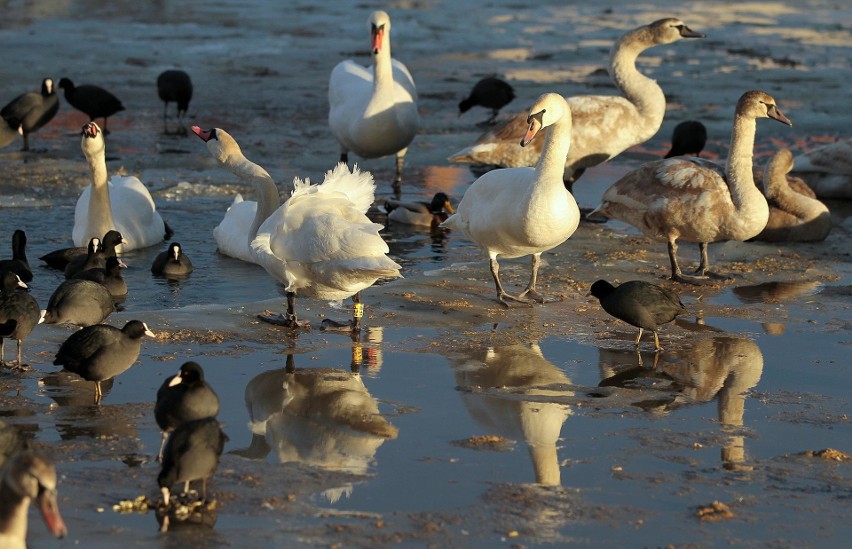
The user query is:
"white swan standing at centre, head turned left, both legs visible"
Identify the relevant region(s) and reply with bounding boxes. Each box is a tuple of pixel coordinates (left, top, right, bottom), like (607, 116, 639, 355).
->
(441, 93, 580, 306)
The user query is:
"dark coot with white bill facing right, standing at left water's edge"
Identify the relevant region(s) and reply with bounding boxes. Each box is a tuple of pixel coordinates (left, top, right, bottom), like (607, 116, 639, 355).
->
(53, 316, 155, 404)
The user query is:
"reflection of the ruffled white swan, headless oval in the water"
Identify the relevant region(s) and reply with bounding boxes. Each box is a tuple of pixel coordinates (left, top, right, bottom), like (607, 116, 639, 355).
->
(235, 353, 398, 503)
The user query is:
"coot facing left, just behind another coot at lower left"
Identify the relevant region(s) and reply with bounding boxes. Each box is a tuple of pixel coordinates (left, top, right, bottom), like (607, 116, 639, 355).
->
(154, 361, 219, 461)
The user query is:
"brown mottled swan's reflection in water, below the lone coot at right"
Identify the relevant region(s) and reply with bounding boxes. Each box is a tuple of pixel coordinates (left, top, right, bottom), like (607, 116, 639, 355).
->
(599, 334, 763, 470)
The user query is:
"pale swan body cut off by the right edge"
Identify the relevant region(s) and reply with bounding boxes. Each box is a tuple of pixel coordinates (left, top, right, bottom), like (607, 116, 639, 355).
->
(793, 139, 852, 200)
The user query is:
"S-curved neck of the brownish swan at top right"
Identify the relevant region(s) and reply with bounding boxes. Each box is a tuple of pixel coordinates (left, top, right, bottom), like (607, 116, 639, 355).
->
(609, 27, 666, 138)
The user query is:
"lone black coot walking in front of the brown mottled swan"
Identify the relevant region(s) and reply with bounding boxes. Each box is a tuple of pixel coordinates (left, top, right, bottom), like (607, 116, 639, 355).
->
(592, 280, 686, 351)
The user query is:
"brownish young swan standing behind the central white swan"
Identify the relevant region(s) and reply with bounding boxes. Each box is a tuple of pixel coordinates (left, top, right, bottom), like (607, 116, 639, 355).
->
(449, 18, 704, 188)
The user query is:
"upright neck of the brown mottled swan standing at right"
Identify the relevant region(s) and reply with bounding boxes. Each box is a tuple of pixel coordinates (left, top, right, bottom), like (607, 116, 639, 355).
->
(725, 113, 769, 216)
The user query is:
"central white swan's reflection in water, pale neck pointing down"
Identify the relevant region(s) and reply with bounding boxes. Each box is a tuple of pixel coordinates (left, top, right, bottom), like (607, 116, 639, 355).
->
(452, 342, 574, 486)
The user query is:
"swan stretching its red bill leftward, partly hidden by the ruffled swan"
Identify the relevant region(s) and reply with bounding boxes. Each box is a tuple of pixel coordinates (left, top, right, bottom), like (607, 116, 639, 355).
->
(192, 126, 281, 263)
